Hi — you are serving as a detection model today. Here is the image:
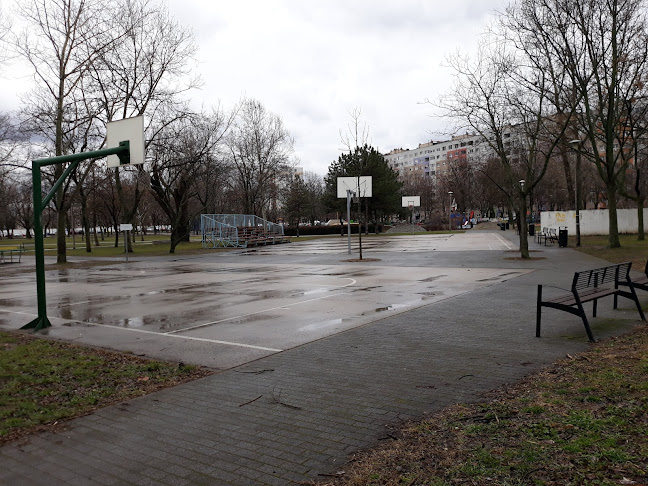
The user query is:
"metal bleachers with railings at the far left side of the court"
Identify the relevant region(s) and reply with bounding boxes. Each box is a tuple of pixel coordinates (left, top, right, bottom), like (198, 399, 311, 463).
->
(200, 214, 290, 248)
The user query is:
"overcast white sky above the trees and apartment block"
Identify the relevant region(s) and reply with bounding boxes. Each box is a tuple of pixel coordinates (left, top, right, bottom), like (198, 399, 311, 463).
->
(0, 0, 508, 175)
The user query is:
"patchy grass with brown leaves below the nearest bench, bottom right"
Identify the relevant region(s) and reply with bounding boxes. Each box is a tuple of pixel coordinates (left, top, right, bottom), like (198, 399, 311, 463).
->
(313, 326, 648, 486)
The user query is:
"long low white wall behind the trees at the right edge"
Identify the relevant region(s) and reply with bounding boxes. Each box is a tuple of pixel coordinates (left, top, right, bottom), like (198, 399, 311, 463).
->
(540, 208, 648, 235)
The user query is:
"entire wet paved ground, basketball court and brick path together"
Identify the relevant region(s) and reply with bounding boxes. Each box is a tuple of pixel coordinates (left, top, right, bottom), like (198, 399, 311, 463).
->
(0, 231, 648, 485)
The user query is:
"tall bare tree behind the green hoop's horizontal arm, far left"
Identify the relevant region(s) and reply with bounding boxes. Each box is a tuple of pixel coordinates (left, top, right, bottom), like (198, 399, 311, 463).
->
(14, 0, 125, 263)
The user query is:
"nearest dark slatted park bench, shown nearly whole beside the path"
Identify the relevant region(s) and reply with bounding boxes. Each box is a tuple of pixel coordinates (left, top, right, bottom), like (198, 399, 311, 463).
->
(536, 262, 646, 342)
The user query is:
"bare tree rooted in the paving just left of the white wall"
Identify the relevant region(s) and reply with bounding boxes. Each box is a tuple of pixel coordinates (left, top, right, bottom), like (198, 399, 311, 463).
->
(440, 40, 569, 258)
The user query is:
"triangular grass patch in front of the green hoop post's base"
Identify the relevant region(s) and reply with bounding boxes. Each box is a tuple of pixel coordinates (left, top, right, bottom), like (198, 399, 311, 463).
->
(0, 331, 212, 443)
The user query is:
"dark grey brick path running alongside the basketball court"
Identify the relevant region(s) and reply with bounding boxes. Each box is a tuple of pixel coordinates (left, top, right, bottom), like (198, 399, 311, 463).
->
(0, 241, 634, 486)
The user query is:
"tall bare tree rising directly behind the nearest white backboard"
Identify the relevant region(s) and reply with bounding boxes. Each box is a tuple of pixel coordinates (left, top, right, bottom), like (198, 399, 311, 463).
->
(90, 0, 200, 251)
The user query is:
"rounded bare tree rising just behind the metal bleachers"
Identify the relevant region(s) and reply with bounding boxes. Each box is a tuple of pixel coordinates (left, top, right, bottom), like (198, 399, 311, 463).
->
(227, 100, 293, 217)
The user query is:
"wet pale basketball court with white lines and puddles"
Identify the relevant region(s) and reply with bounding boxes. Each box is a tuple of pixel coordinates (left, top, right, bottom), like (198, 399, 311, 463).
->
(0, 231, 529, 369)
